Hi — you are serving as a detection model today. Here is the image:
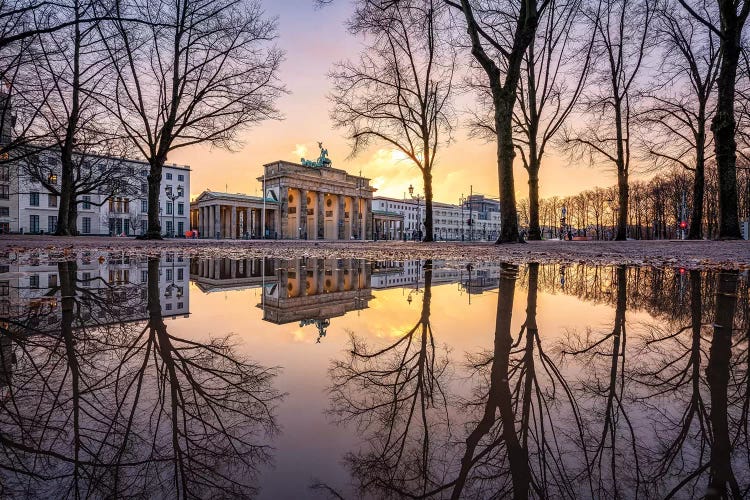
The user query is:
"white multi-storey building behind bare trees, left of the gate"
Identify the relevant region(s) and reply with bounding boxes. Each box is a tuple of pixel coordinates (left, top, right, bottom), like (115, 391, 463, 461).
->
(5, 152, 190, 236)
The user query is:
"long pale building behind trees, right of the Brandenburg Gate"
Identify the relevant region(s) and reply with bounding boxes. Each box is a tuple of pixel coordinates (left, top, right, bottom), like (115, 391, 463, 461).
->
(372, 195, 500, 241)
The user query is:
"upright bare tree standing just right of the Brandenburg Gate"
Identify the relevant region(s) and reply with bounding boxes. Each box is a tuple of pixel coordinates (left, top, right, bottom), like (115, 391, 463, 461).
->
(330, 0, 455, 241)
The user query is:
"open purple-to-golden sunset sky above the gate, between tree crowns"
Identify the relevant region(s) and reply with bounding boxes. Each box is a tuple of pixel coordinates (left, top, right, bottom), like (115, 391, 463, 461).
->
(168, 0, 616, 203)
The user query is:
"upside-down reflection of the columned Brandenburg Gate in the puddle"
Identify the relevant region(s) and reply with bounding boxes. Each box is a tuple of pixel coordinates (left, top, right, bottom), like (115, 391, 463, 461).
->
(258, 259, 372, 324)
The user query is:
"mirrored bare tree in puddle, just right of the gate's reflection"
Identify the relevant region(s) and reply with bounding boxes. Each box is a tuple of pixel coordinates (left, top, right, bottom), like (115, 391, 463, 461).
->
(330, 260, 450, 496)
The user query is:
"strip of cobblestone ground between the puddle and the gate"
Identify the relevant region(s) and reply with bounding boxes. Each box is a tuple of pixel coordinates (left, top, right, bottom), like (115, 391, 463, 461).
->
(0, 235, 750, 270)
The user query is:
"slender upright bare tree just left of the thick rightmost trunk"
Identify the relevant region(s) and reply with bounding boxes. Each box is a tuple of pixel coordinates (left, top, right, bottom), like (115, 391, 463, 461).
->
(639, 1, 719, 239)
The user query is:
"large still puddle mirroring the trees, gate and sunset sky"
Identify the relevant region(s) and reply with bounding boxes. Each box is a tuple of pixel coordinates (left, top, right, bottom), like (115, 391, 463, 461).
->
(0, 254, 750, 499)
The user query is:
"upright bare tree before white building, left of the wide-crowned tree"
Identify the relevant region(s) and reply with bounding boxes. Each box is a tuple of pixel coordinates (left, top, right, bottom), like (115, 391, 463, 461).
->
(19, 0, 132, 235)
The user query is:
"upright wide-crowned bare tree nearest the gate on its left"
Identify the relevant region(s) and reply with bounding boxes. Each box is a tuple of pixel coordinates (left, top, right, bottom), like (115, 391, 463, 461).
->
(102, 0, 284, 239)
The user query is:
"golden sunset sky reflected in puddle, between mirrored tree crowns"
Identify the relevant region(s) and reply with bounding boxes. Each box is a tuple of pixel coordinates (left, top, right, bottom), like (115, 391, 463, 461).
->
(169, 276, 628, 498)
